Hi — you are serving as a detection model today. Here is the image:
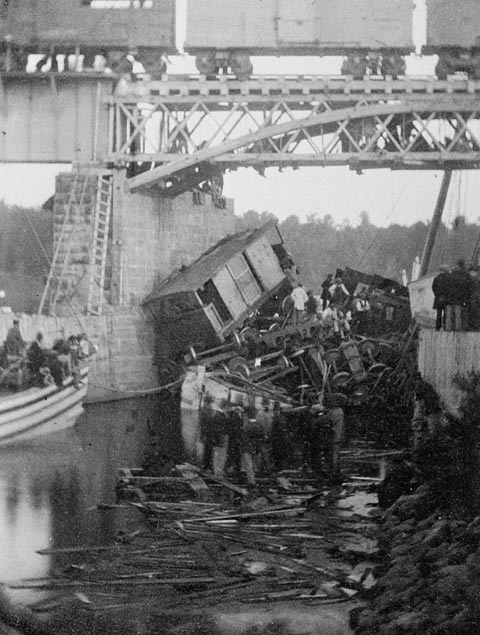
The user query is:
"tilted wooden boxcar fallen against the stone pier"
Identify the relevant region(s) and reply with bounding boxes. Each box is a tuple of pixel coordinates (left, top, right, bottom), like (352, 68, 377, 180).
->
(144, 221, 291, 380)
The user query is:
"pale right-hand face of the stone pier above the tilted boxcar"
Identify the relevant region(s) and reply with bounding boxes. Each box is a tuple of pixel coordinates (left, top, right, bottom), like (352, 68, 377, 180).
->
(111, 175, 234, 306)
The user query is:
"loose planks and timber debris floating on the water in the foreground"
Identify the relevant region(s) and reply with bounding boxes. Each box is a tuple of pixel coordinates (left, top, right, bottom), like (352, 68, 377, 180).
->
(3, 465, 384, 633)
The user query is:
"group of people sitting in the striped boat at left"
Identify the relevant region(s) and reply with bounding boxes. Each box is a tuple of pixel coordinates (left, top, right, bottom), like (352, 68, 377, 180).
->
(0, 320, 90, 388)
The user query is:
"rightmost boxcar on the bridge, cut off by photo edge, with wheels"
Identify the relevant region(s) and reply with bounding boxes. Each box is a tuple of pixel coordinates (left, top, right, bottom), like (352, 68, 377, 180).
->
(423, 0, 480, 79)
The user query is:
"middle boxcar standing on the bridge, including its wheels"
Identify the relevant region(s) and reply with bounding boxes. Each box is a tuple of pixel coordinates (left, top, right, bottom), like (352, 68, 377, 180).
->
(185, 0, 414, 79)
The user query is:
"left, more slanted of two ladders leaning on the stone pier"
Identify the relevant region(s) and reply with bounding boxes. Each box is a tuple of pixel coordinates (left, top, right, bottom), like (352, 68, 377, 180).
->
(38, 170, 89, 315)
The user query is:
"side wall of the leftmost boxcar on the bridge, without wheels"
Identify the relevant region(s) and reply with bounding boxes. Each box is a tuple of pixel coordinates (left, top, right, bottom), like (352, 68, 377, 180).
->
(5, 0, 175, 52)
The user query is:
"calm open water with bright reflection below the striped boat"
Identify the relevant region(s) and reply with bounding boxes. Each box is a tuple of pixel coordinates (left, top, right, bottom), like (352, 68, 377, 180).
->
(0, 398, 158, 602)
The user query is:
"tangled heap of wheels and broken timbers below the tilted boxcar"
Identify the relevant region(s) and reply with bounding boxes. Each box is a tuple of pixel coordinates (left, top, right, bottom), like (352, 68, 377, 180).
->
(178, 319, 416, 428)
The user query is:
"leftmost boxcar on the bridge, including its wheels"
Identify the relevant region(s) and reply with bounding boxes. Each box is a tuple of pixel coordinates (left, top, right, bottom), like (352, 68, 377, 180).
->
(0, 0, 176, 75)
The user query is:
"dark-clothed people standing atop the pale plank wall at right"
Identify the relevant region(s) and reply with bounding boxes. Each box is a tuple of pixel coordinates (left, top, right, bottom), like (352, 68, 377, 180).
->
(432, 260, 480, 331)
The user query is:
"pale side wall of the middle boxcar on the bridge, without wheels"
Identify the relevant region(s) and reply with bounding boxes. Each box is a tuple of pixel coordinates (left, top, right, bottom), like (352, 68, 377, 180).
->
(185, 0, 413, 54)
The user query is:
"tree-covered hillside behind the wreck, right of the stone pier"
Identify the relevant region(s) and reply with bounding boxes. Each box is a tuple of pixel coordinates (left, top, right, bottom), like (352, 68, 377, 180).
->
(237, 211, 480, 290)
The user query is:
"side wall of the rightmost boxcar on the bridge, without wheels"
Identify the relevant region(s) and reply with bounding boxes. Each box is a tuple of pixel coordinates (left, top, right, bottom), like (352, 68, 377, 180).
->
(426, 0, 480, 51)
